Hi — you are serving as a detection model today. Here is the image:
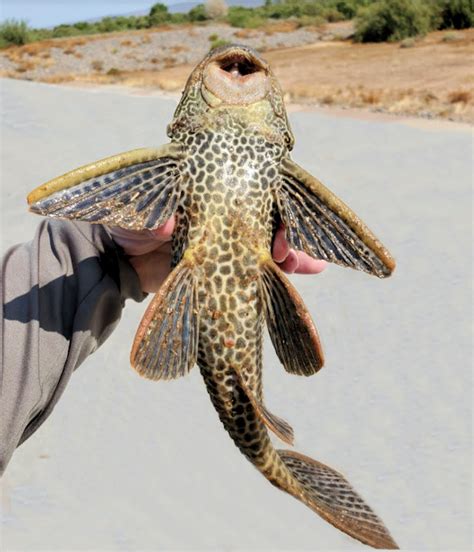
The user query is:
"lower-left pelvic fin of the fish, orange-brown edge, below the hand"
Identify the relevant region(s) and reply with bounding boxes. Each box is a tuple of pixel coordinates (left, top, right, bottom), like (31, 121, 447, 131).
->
(130, 259, 198, 380)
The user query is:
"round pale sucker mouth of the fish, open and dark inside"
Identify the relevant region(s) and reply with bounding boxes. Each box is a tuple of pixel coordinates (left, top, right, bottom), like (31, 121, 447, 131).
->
(203, 45, 270, 105)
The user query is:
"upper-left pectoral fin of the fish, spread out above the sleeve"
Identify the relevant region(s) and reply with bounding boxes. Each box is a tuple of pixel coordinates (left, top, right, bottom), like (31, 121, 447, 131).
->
(28, 144, 183, 230)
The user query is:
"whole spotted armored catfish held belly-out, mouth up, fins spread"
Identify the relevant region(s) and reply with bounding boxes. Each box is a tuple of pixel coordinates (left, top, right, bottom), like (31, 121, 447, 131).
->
(28, 45, 397, 549)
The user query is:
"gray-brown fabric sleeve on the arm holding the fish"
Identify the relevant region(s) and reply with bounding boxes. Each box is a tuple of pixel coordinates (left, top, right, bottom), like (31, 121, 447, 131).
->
(0, 220, 144, 473)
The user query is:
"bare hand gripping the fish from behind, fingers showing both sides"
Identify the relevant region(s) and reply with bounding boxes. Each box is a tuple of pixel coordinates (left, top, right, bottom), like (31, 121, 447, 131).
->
(110, 217, 326, 293)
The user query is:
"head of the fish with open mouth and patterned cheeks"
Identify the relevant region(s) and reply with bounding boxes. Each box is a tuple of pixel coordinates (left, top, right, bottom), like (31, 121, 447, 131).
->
(168, 44, 294, 149)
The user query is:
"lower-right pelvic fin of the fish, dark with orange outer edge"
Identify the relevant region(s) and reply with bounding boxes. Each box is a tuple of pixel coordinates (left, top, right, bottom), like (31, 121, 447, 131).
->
(260, 259, 324, 376)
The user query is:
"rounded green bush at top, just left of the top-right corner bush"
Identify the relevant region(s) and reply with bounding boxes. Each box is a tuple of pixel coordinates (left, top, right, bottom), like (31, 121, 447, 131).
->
(354, 0, 432, 42)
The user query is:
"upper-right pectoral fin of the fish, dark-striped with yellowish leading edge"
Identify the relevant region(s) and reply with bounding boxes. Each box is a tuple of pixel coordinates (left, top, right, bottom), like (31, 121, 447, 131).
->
(277, 158, 395, 278)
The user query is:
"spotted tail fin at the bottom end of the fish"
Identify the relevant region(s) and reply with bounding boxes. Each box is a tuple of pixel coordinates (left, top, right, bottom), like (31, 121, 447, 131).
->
(278, 450, 398, 550)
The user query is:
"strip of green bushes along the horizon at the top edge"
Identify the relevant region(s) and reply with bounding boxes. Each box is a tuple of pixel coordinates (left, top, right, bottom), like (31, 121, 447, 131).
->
(0, 0, 474, 47)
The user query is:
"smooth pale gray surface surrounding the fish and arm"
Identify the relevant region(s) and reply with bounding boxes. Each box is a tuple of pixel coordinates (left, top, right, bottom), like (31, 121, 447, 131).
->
(1, 81, 472, 551)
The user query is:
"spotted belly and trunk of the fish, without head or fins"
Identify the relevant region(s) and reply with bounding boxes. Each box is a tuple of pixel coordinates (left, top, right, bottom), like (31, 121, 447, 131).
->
(174, 108, 291, 481)
